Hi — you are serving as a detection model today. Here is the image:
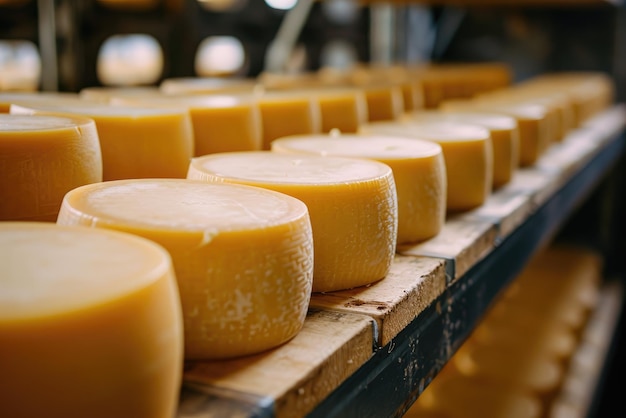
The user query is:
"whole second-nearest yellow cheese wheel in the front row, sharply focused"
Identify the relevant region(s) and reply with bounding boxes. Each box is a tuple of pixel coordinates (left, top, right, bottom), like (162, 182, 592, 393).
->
(58, 179, 313, 359)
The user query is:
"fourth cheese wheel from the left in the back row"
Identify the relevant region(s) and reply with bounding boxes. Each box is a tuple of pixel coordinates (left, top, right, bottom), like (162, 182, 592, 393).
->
(254, 90, 322, 150)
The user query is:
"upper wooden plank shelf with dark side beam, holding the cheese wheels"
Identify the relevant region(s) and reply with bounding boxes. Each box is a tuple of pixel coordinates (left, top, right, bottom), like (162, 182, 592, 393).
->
(177, 105, 626, 418)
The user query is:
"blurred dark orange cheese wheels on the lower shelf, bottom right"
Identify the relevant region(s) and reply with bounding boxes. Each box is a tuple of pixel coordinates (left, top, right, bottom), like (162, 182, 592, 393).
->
(404, 244, 603, 418)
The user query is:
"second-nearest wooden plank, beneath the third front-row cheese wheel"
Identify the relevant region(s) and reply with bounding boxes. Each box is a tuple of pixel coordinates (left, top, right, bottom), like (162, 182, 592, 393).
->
(311, 255, 446, 347)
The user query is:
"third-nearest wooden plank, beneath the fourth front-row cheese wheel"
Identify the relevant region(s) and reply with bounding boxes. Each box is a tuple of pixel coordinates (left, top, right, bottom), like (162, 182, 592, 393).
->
(398, 214, 497, 282)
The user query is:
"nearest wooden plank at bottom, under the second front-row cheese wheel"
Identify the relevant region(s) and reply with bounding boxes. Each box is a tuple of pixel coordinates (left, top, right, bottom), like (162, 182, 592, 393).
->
(178, 309, 374, 418)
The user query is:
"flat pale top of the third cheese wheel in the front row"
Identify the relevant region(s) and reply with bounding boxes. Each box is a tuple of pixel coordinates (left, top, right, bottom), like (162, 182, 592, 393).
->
(191, 151, 391, 185)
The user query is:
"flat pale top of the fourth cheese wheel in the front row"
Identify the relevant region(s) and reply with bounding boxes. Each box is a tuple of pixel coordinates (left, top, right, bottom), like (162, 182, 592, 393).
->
(272, 134, 442, 160)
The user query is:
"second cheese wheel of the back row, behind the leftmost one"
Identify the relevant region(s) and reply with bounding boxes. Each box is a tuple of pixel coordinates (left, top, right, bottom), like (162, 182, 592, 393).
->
(11, 100, 194, 181)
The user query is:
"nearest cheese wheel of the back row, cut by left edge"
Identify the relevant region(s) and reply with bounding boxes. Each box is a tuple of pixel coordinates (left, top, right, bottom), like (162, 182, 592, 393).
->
(0, 114, 102, 222)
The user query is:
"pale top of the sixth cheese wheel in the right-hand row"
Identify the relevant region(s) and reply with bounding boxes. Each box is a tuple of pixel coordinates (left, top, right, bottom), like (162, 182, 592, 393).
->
(403, 110, 517, 131)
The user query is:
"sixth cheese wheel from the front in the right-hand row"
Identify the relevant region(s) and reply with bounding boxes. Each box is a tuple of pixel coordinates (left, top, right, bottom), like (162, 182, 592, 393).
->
(402, 110, 519, 189)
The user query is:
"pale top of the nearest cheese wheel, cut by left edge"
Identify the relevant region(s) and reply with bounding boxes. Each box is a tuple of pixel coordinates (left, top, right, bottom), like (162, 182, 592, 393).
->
(0, 222, 171, 322)
